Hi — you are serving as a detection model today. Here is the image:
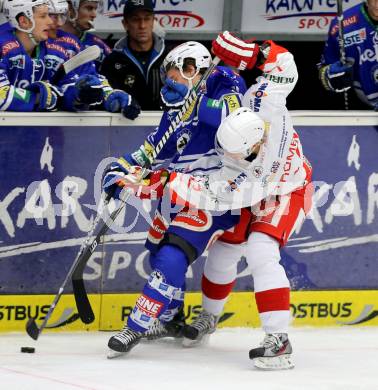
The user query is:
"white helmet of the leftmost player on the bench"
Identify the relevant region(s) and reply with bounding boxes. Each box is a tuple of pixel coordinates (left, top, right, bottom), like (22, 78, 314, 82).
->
(3, 0, 49, 33)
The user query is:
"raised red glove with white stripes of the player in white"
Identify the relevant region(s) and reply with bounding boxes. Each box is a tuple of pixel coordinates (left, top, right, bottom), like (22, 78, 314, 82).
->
(212, 31, 259, 70)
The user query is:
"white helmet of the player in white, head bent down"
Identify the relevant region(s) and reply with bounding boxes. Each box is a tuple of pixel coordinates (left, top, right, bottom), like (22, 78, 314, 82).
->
(216, 107, 265, 158)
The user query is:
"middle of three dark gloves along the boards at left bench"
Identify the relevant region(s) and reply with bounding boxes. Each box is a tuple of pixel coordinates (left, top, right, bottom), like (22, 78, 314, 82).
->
(75, 74, 105, 106)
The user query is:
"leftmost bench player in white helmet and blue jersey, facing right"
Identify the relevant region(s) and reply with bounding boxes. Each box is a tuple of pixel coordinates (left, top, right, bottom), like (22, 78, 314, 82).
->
(0, 0, 97, 111)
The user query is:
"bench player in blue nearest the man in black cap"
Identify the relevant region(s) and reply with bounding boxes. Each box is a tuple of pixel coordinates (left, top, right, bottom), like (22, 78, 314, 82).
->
(61, 0, 112, 70)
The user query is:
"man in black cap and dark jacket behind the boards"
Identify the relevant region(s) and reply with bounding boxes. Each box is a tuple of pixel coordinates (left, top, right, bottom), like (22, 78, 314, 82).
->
(100, 0, 167, 110)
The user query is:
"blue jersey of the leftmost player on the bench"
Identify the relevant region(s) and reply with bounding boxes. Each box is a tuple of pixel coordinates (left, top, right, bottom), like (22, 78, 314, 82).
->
(0, 29, 92, 112)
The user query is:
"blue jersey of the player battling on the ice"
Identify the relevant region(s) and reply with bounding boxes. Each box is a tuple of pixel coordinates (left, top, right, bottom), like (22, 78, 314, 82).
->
(132, 67, 246, 174)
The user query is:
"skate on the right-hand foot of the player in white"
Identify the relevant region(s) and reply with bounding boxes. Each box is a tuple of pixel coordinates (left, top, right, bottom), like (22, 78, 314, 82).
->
(249, 333, 294, 370)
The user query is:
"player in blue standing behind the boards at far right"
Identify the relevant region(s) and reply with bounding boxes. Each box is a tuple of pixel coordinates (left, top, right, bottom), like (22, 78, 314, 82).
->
(319, 0, 378, 110)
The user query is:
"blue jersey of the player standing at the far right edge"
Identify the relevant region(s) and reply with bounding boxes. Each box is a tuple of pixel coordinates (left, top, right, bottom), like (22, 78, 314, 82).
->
(321, 4, 378, 106)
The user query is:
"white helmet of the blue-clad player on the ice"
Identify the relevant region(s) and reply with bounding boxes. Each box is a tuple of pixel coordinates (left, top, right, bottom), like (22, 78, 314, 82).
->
(160, 41, 211, 84)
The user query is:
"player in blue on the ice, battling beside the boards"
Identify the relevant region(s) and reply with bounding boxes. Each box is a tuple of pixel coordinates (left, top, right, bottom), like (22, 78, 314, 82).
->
(100, 42, 252, 352)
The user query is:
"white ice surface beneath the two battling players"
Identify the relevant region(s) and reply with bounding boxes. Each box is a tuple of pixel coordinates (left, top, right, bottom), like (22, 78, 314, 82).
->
(0, 327, 378, 390)
